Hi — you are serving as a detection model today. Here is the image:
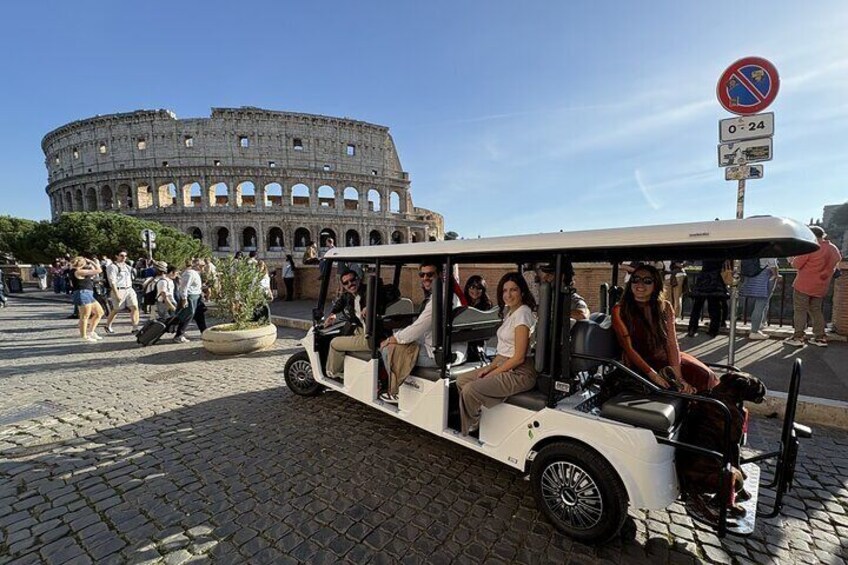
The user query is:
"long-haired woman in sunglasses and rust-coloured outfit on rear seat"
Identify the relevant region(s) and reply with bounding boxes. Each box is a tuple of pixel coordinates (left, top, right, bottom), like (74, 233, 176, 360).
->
(612, 264, 718, 394)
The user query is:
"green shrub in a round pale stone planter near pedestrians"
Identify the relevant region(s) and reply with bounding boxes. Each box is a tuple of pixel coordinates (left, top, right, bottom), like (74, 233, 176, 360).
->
(203, 258, 277, 355)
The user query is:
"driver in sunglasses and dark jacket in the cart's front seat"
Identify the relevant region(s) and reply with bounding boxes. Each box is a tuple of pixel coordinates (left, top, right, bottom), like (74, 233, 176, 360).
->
(324, 269, 370, 379)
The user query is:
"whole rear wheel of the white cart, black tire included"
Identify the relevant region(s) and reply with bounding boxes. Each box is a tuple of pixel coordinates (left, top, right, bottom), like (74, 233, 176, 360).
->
(530, 441, 627, 544)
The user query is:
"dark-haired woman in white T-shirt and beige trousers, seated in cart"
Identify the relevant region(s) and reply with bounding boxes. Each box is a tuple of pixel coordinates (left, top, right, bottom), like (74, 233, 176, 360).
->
(456, 272, 536, 435)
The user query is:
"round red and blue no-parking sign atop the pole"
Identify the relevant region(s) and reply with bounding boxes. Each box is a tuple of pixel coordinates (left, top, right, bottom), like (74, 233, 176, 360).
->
(716, 57, 780, 116)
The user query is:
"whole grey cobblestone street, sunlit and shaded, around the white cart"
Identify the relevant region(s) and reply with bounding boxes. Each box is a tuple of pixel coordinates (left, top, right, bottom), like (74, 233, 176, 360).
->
(0, 300, 848, 565)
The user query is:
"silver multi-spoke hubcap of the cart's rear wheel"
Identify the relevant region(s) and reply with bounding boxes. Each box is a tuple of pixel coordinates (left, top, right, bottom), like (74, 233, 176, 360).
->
(542, 461, 604, 530)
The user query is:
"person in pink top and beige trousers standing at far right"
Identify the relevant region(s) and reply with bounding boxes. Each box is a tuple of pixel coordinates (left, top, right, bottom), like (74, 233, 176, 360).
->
(784, 226, 842, 347)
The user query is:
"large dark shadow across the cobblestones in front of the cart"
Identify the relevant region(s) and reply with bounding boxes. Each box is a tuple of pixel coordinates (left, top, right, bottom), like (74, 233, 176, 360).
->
(0, 386, 836, 563)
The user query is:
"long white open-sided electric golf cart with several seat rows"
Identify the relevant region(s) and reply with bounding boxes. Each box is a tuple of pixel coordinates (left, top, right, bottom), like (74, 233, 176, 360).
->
(285, 218, 817, 543)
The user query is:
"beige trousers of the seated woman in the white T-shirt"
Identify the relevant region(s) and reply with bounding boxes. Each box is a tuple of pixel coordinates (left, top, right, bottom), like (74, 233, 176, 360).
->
(456, 355, 536, 435)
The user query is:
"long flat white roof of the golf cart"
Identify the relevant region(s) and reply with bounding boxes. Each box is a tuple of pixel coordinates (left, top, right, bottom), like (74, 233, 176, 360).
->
(326, 217, 818, 264)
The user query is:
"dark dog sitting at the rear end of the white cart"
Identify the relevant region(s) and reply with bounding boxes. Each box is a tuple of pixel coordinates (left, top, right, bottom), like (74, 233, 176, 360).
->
(676, 372, 766, 515)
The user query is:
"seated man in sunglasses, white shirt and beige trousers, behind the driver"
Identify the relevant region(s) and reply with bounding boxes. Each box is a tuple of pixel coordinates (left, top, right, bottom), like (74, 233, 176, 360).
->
(380, 263, 442, 404)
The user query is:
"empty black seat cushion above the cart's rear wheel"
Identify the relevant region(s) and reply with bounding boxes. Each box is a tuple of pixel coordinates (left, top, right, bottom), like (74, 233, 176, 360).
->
(601, 392, 686, 434)
